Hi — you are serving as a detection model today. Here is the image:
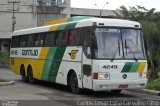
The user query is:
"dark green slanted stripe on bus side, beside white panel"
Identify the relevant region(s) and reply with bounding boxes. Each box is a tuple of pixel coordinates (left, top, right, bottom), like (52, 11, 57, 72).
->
(48, 47, 66, 82)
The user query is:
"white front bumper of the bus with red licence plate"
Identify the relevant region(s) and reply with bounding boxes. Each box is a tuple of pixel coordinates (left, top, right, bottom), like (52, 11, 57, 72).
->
(93, 79, 147, 91)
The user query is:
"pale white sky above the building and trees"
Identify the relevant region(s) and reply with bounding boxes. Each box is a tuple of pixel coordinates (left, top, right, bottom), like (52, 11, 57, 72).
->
(71, 0, 160, 11)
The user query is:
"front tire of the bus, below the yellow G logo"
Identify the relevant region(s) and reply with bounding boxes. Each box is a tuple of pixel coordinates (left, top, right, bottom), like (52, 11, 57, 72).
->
(69, 72, 82, 94)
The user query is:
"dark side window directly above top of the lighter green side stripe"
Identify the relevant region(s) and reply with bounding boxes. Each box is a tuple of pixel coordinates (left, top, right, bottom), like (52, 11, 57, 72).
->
(45, 32, 56, 46)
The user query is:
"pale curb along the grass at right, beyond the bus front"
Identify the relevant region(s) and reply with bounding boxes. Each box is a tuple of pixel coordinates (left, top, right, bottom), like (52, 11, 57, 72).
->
(129, 89, 160, 96)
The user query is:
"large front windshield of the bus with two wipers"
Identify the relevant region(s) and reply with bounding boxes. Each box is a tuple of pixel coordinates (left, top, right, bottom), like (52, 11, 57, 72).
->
(92, 28, 146, 59)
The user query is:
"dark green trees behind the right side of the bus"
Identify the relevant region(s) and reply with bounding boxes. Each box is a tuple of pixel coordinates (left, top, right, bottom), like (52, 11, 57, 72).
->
(115, 5, 160, 79)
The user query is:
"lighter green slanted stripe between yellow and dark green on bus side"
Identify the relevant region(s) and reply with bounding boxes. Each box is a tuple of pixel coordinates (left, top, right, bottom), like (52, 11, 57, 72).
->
(42, 47, 57, 80)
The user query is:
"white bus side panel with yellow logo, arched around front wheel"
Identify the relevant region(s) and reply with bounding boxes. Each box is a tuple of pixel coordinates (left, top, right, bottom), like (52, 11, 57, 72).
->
(56, 46, 82, 88)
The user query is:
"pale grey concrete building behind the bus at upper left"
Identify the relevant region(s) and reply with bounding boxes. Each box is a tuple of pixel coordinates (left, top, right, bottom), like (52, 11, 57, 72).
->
(0, 0, 115, 51)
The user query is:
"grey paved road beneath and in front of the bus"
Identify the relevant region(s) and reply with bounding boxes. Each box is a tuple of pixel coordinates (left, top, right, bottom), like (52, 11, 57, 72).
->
(0, 69, 160, 106)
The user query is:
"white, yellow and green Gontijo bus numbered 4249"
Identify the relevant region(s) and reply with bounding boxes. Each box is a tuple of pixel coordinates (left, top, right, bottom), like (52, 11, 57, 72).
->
(10, 16, 147, 93)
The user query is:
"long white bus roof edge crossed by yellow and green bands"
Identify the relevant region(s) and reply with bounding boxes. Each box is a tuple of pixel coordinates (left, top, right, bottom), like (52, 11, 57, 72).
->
(13, 17, 141, 36)
